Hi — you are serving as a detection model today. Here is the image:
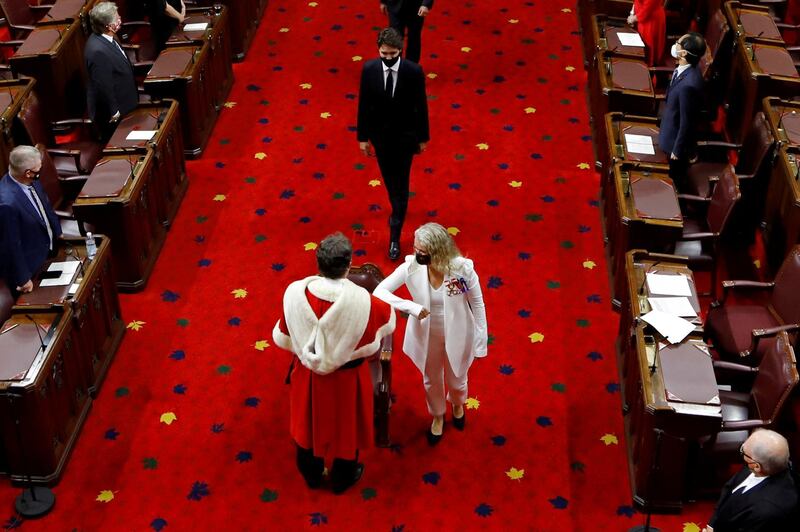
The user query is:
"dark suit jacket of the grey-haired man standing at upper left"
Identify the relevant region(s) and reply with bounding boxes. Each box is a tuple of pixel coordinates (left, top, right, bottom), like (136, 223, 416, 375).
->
(83, 33, 139, 128)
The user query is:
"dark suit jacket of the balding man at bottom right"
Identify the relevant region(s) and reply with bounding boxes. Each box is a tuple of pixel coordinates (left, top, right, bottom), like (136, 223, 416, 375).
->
(708, 467, 798, 532)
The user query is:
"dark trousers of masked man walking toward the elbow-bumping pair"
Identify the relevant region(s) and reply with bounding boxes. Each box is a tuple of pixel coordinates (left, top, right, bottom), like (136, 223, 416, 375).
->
(373, 142, 414, 242)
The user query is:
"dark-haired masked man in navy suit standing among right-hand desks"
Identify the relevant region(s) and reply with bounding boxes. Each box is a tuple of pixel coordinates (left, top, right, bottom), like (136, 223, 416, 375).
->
(658, 32, 706, 188)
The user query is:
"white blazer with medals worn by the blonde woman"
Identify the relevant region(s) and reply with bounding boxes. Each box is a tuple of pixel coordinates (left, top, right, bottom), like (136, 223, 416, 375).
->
(373, 255, 488, 377)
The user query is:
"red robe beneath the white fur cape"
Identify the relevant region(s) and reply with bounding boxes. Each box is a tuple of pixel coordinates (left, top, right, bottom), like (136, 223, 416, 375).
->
(273, 278, 394, 461)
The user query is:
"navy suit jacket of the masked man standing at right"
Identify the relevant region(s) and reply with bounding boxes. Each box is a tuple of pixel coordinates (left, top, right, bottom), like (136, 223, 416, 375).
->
(658, 66, 703, 159)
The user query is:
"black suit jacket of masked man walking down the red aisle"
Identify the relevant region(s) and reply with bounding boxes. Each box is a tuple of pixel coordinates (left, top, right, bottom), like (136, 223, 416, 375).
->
(358, 59, 430, 150)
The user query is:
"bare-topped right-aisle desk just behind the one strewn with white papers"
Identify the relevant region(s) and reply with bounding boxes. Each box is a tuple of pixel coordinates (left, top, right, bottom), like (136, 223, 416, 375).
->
(603, 163, 680, 308)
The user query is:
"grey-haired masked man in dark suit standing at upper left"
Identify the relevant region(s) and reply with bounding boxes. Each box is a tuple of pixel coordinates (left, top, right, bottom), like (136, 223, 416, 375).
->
(84, 2, 139, 139)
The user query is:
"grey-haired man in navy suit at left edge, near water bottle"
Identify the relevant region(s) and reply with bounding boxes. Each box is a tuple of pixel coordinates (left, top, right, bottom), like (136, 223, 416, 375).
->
(0, 146, 61, 293)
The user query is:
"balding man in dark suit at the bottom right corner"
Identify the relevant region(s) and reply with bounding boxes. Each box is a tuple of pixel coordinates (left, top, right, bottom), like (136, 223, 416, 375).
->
(704, 430, 800, 532)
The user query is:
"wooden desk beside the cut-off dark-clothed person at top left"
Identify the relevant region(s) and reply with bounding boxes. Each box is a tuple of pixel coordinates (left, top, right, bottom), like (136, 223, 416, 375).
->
(167, 4, 233, 111)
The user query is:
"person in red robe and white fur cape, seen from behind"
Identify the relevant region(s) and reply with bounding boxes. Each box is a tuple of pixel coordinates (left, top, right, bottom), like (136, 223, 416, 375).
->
(272, 233, 395, 494)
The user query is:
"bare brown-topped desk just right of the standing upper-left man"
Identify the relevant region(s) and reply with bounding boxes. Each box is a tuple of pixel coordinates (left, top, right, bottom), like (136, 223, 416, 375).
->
(144, 41, 219, 159)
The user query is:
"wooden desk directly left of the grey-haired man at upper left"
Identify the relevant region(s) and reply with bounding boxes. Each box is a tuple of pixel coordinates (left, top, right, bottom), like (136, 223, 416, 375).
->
(9, 22, 86, 121)
